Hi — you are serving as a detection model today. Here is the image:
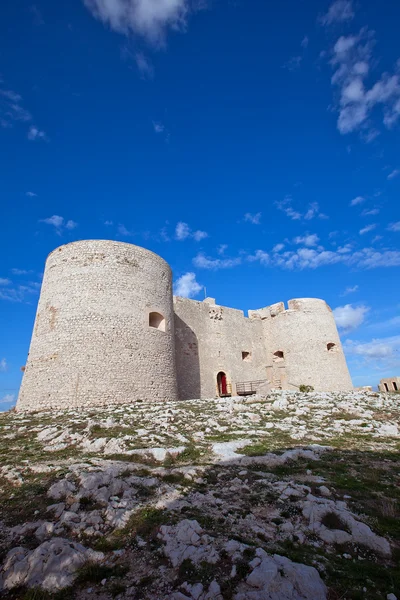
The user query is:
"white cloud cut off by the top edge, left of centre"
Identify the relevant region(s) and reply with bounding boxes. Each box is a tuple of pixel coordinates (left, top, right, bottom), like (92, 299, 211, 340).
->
(83, 0, 191, 44)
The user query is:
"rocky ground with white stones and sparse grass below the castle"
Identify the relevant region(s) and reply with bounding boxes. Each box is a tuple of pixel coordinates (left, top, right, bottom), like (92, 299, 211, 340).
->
(0, 391, 400, 600)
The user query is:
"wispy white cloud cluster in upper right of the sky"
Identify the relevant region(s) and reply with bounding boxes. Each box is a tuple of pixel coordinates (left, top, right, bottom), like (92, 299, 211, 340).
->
(331, 28, 400, 136)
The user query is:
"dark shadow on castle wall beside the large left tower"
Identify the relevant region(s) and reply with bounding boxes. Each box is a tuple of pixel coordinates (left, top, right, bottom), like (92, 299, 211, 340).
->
(175, 315, 201, 400)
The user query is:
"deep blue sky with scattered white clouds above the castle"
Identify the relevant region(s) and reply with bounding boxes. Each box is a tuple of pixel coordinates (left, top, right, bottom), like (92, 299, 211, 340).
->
(0, 0, 400, 409)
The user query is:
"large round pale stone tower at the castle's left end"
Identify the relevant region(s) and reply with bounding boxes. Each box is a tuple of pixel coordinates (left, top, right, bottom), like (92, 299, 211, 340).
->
(17, 240, 177, 411)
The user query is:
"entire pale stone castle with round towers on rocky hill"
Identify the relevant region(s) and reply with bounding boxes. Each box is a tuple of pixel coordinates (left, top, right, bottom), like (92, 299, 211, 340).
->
(17, 240, 353, 411)
